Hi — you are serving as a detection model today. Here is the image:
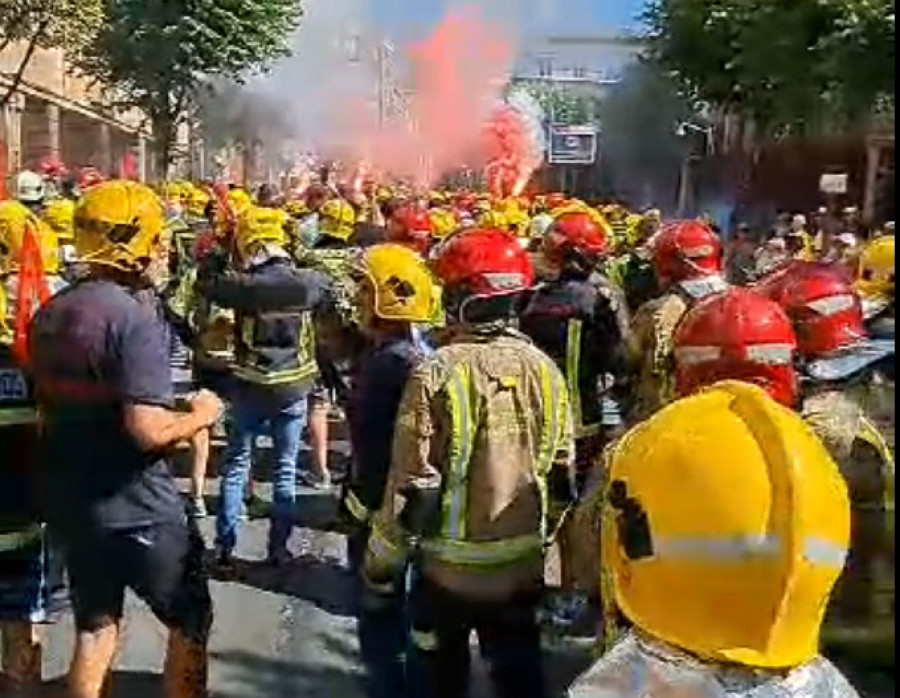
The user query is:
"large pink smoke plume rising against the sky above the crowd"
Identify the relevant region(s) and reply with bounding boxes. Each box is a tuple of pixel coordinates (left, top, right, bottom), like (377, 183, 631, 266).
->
(338, 6, 524, 188)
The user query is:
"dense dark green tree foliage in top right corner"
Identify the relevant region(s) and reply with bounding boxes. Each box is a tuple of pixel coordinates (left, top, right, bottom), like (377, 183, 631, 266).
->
(645, 0, 894, 134)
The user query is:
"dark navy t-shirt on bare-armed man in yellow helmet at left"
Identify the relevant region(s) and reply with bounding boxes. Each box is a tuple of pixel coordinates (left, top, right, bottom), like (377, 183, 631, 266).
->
(31, 281, 184, 528)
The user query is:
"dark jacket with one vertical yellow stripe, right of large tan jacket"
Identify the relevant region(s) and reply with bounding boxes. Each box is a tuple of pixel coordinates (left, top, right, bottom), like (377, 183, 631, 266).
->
(519, 278, 628, 440)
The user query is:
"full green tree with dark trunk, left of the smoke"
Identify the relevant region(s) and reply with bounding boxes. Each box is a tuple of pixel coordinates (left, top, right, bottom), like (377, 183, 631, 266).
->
(75, 0, 302, 173)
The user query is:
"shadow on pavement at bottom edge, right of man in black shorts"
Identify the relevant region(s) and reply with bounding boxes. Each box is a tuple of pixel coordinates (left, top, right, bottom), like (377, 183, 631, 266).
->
(211, 652, 364, 698)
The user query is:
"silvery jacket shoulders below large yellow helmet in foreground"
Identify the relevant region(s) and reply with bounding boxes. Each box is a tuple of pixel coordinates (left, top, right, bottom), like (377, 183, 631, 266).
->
(568, 632, 859, 698)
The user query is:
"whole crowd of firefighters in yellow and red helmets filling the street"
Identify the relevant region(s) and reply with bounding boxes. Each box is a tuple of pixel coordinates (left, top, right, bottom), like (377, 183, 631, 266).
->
(0, 158, 894, 698)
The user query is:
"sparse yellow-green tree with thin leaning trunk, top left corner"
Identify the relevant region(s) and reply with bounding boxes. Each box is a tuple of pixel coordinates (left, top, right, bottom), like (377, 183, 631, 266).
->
(0, 0, 103, 108)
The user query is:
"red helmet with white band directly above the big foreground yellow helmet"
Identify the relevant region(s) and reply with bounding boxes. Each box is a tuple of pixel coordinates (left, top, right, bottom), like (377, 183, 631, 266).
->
(674, 288, 799, 407)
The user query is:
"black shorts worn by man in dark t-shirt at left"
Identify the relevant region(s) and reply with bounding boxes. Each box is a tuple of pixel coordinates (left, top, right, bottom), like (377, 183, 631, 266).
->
(66, 521, 212, 642)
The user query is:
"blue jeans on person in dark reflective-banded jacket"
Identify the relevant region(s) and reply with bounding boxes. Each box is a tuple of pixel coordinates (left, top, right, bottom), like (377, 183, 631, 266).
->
(216, 395, 306, 555)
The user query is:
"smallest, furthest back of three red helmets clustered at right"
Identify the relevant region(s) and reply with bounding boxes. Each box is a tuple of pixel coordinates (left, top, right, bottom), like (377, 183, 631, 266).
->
(650, 216, 722, 286)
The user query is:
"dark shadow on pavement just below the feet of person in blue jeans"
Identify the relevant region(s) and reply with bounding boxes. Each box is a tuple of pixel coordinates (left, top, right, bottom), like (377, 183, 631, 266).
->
(223, 555, 356, 617)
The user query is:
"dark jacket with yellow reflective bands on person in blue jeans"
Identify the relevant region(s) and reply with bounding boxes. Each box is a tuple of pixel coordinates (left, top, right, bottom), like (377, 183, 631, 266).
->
(203, 256, 328, 399)
